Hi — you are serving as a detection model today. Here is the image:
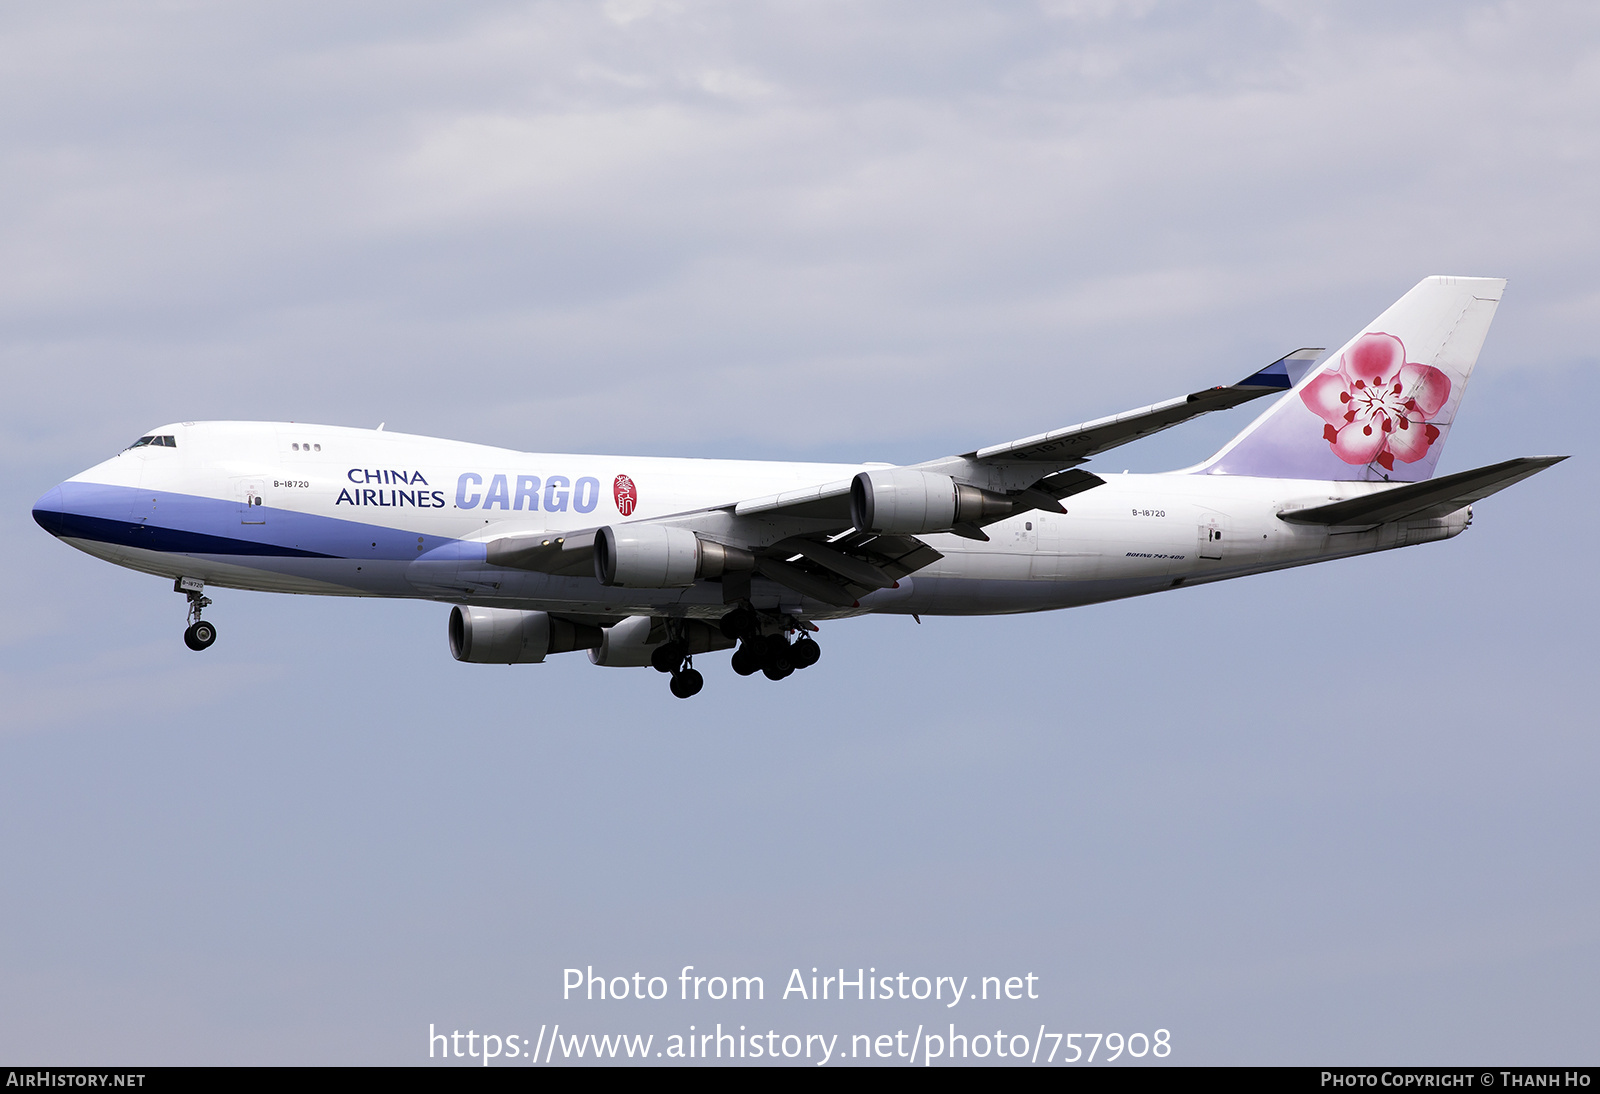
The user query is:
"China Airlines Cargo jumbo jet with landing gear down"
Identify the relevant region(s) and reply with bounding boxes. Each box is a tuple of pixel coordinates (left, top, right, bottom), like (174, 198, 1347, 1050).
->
(34, 277, 1563, 697)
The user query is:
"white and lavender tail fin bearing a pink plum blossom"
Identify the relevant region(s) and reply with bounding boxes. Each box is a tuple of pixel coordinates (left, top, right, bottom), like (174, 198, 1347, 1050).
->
(1195, 277, 1506, 483)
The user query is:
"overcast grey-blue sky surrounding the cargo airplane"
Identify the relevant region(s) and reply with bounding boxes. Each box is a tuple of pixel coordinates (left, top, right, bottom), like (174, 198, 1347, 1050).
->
(0, 0, 1600, 1064)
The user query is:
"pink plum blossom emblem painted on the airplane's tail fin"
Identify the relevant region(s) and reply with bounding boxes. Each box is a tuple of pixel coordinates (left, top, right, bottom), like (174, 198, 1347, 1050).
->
(1301, 333, 1450, 470)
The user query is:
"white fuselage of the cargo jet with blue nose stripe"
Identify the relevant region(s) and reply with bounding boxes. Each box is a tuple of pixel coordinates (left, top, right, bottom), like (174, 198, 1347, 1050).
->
(40, 422, 1470, 619)
